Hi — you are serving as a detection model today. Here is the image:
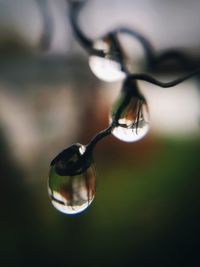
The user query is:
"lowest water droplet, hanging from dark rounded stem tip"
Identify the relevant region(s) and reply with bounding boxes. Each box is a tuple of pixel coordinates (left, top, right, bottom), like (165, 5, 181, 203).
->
(48, 144, 95, 214)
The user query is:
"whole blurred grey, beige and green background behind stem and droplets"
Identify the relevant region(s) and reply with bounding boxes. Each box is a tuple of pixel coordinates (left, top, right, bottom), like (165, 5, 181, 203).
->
(0, 0, 200, 266)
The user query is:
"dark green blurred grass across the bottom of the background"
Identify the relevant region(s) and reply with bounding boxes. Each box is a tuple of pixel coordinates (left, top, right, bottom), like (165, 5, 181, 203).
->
(1, 139, 200, 266)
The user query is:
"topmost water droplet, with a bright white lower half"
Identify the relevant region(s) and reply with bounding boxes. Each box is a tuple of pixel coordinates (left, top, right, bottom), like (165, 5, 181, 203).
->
(89, 34, 126, 82)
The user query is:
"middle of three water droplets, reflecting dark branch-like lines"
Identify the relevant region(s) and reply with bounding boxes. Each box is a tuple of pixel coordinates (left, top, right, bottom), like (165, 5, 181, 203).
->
(110, 79, 149, 142)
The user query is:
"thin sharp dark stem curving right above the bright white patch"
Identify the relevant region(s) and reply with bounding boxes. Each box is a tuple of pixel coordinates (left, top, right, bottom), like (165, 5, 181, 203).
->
(127, 69, 200, 88)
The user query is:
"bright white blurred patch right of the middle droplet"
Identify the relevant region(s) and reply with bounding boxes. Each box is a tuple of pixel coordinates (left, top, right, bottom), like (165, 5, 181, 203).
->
(141, 80, 200, 138)
